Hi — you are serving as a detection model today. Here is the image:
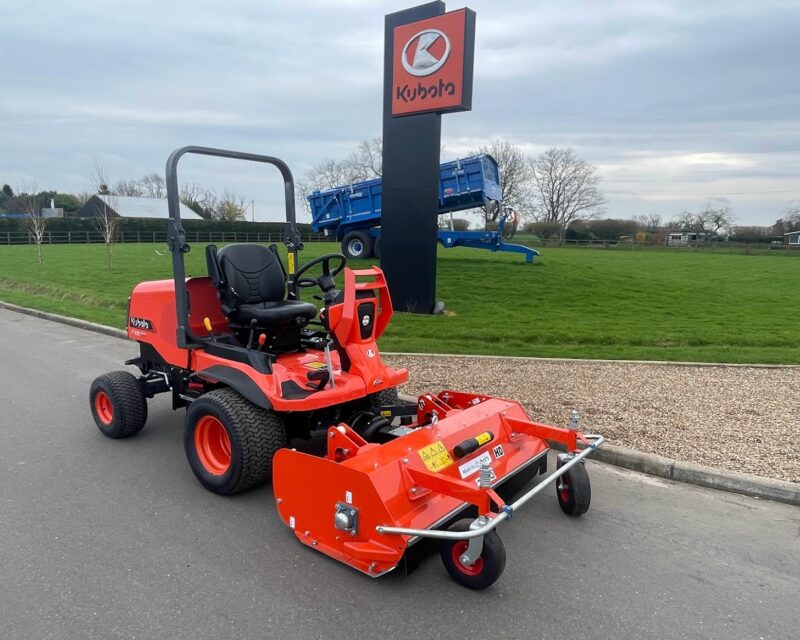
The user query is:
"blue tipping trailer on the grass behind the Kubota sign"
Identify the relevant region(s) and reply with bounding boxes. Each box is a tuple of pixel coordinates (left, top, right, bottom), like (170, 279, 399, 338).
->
(308, 154, 540, 263)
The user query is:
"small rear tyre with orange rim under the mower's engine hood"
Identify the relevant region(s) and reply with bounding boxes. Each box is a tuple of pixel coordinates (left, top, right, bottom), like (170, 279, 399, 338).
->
(89, 371, 147, 438)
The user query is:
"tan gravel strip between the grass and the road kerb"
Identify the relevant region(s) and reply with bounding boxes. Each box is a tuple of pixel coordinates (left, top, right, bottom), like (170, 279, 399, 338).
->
(384, 355, 800, 482)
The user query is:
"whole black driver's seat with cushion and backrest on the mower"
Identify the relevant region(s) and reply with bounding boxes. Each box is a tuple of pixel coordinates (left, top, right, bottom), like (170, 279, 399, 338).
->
(214, 244, 317, 328)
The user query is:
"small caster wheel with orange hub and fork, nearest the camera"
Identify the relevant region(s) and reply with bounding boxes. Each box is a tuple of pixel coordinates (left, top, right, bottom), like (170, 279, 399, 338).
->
(441, 518, 506, 590)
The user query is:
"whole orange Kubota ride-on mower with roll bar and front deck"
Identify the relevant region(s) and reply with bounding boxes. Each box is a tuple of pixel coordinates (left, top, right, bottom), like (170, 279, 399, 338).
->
(90, 147, 603, 589)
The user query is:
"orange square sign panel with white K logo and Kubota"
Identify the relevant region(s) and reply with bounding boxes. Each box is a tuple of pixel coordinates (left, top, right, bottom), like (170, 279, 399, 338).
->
(392, 9, 474, 116)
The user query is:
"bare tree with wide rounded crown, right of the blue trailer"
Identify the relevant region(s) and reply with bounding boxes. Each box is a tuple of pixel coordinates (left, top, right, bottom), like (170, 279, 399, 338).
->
(530, 148, 606, 240)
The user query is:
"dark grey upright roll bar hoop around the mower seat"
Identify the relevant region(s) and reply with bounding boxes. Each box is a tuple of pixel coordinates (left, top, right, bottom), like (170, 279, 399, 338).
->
(166, 146, 303, 349)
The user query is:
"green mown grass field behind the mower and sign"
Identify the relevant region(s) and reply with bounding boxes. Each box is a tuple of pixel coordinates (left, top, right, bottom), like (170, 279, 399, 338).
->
(0, 244, 800, 362)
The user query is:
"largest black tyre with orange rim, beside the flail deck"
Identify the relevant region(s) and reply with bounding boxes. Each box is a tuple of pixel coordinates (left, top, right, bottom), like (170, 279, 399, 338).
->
(183, 389, 286, 495)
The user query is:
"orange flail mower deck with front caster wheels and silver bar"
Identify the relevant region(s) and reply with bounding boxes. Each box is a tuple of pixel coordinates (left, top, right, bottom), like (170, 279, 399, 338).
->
(273, 391, 603, 589)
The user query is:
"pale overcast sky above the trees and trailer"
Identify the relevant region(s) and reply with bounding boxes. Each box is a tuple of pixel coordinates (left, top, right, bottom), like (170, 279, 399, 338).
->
(0, 0, 800, 224)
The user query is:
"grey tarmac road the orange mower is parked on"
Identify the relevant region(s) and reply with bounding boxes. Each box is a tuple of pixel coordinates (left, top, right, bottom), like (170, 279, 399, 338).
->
(0, 310, 800, 640)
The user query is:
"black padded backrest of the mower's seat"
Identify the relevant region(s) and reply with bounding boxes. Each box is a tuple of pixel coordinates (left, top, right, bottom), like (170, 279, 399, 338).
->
(217, 244, 286, 307)
